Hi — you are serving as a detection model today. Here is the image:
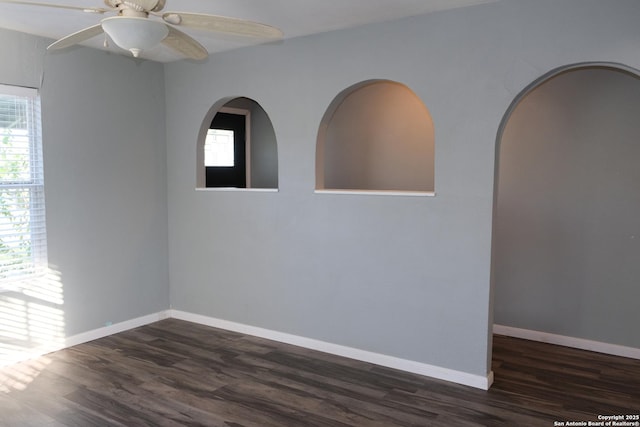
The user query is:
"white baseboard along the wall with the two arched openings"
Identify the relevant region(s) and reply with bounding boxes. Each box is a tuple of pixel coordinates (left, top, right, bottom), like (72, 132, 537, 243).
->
(169, 310, 493, 390)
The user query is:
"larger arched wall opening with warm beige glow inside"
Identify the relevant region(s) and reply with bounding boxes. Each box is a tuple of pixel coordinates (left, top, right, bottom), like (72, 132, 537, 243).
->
(316, 80, 435, 195)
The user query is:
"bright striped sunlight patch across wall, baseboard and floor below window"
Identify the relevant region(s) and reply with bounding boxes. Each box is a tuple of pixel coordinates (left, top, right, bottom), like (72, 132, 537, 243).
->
(0, 269, 65, 393)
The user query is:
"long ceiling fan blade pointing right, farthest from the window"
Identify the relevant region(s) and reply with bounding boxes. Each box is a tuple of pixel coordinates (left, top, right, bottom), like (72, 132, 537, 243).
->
(162, 12, 283, 39)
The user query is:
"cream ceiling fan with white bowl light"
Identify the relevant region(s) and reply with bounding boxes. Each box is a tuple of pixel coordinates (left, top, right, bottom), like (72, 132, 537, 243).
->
(0, 0, 283, 60)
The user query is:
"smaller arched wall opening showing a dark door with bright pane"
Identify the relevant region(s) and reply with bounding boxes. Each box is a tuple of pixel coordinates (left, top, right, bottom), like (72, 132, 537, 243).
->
(197, 97, 278, 189)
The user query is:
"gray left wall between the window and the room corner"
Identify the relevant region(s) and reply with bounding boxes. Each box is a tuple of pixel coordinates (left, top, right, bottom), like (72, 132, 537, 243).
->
(0, 30, 169, 344)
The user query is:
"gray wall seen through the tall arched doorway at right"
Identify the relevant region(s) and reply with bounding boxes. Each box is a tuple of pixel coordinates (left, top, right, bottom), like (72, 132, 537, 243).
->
(494, 68, 640, 348)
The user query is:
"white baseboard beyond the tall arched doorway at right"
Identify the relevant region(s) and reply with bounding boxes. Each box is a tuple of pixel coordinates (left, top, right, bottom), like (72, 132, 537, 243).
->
(493, 325, 640, 359)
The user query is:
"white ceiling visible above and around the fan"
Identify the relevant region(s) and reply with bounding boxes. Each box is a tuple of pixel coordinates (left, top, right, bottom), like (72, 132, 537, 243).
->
(0, 0, 495, 62)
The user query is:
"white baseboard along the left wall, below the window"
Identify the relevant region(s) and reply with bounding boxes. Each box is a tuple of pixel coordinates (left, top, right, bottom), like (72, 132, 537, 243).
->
(0, 310, 169, 367)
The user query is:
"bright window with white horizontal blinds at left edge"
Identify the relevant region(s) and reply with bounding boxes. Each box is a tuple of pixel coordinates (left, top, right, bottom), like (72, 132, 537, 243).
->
(0, 85, 47, 288)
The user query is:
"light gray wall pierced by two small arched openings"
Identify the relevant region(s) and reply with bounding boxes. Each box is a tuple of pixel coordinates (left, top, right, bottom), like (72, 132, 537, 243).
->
(165, 0, 640, 375)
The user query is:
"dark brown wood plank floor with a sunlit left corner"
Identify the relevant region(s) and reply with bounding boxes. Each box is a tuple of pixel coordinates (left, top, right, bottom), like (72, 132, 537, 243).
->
(0, 319, 640, 427)
